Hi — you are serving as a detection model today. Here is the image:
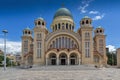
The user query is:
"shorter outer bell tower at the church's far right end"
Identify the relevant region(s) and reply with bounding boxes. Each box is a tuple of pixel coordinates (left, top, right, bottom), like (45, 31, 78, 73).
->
(94, 26, 107, 66)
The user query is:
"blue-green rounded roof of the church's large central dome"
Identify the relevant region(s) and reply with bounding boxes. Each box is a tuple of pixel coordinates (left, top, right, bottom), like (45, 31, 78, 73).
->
(54, 8, 73, 19)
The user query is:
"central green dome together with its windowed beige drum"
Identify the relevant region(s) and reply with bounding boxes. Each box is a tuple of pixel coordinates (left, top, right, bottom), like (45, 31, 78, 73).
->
(51, 8, 75, 31)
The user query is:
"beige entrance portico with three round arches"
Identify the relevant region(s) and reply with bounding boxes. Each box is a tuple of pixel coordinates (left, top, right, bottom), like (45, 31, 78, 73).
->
(46, 51, 81, 65)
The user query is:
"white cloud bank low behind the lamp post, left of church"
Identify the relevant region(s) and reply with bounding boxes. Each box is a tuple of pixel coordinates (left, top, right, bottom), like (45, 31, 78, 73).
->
(0, 38, 21, 54)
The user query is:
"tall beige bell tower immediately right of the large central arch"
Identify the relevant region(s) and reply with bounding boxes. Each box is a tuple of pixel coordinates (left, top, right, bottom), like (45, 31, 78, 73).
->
(79, 16, 93, 64)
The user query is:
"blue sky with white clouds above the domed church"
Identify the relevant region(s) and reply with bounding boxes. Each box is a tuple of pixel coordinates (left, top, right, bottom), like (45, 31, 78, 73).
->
(0, 0, 120, 53)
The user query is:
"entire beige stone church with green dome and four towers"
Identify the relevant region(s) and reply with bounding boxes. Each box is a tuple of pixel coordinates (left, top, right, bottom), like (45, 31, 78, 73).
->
(21, 8, 107, 67)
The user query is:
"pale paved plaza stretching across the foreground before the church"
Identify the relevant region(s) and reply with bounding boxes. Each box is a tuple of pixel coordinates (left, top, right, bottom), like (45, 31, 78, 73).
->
(0, 66, 120, 80)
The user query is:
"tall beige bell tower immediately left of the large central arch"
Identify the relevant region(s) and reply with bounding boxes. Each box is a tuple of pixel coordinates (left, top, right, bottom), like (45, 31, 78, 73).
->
(33, 18, 48, 65)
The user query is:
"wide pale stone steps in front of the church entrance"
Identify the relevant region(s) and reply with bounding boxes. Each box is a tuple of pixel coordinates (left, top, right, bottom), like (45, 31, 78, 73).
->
(28, 65, 96, 71)
